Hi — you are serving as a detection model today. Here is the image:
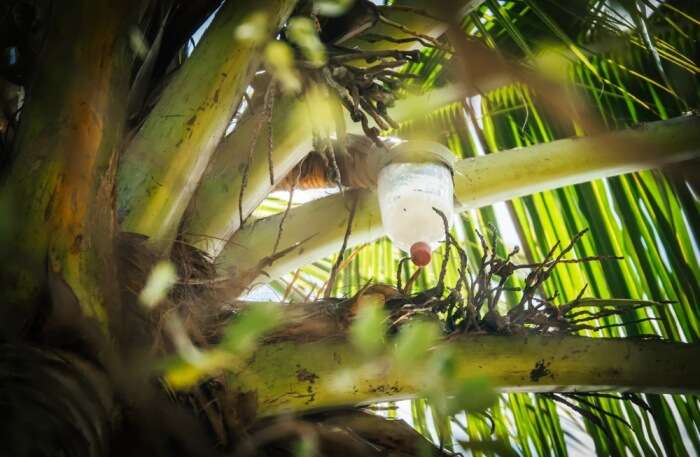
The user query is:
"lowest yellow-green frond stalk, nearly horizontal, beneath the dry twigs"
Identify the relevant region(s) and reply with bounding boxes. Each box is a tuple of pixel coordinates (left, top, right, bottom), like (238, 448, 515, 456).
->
(231, 336, 700, 416)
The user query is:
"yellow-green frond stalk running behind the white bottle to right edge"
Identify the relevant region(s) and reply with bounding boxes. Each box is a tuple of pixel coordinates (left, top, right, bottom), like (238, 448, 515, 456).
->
(217, 116, 700, 280)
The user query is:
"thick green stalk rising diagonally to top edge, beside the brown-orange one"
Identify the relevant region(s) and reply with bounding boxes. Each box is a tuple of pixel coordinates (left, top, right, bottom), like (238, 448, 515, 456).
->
(118, 0, 296, 250)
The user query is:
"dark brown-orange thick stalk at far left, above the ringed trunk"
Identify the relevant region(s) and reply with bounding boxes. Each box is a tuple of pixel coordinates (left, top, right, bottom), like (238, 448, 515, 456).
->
(0, 0, 145, 338)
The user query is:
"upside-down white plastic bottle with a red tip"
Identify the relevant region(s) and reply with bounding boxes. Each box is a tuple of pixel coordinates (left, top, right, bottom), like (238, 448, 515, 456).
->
(377, 160, 454, 266)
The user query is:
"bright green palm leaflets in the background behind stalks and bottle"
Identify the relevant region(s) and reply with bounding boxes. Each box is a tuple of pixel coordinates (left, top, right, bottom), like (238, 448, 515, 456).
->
(243, 0, 700, 456)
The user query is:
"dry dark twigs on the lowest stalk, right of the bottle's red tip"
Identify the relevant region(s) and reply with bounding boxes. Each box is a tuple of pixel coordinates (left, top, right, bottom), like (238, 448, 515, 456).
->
(378, 209, 667, 334)
